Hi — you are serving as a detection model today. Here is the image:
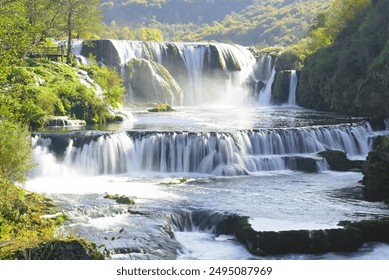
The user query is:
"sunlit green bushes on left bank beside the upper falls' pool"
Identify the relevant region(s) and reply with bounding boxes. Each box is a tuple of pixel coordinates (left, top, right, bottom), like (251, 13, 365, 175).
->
(0, 59, 124, 128)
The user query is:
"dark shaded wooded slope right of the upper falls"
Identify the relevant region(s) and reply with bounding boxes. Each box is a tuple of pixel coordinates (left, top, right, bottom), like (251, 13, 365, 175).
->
(298, 0, 389, 116)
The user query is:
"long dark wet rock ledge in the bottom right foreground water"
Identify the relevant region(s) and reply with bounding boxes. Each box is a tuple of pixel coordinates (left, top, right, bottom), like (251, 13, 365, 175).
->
(217, 215, 364, 256)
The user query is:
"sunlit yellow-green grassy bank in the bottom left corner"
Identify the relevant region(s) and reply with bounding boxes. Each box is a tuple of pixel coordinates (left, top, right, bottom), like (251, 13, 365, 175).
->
(0, 178, 102, 260)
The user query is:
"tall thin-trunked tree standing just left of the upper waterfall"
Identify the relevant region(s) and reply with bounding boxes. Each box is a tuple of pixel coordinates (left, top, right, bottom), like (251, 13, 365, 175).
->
(58, 0, 103, 63)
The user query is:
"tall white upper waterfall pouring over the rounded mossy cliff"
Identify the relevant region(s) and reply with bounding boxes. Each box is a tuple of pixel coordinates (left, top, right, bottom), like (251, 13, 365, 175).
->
(73, 40, 256, 105)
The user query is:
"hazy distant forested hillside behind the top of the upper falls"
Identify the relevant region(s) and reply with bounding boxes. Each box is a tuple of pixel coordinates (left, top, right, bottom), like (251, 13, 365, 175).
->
(102, 0, 330, 46)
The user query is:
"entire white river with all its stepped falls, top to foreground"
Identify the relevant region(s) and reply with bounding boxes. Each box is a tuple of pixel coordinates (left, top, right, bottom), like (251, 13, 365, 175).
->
(27, 40, 387, 259)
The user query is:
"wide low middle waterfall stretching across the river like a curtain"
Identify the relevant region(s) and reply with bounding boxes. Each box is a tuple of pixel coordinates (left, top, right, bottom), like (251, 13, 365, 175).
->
(33, 123, 372, 176)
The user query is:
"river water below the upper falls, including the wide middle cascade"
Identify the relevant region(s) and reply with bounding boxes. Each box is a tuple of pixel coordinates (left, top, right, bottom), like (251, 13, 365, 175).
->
(26, 106, 389, 260)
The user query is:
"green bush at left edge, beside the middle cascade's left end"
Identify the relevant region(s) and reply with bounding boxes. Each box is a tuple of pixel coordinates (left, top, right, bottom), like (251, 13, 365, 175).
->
(0, 119, 32, 183)
